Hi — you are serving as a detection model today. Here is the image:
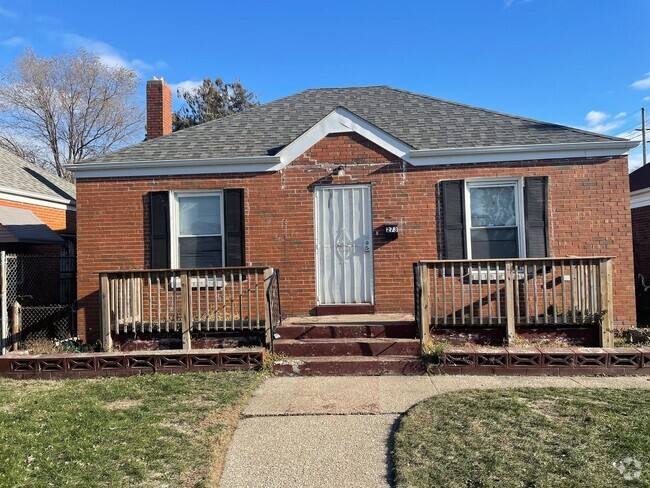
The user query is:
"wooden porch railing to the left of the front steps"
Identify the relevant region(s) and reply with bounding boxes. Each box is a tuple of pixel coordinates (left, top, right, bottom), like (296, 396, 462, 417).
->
(99, 267, 281, 350)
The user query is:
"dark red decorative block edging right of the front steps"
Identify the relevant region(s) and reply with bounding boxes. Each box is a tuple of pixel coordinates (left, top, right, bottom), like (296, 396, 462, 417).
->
(429, 347, 650, 376)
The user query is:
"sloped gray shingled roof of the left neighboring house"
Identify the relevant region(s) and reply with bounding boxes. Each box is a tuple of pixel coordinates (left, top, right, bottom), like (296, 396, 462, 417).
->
(0, 147, 75, 200)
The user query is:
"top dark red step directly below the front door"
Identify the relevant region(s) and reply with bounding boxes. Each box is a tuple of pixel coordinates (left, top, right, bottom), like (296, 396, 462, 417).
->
(275, 322, 417, 339)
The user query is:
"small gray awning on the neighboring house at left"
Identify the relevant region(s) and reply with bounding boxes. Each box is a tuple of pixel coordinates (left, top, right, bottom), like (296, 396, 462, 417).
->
(0, 206, 63, 244)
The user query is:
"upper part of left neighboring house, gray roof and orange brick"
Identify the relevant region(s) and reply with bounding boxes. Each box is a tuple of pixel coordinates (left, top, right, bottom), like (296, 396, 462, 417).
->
(0, 148, 76, 255)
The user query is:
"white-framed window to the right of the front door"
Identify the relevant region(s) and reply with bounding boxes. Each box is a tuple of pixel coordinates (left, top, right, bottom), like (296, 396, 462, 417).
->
(465, 179, 526, 259)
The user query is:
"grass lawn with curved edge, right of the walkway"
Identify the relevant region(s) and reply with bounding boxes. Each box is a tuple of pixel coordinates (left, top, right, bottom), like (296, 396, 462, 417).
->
(394, 388, 650, 488)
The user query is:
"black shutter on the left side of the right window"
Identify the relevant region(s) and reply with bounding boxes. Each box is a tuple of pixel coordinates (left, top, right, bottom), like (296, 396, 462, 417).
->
(440, 180, 467, 259)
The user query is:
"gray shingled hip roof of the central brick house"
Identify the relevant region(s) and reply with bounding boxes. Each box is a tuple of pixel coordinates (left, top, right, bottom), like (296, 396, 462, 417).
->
(83, 86, 621, 162)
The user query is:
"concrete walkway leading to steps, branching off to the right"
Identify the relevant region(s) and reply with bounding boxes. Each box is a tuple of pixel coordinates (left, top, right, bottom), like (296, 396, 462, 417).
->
(221, 376, 650, 488)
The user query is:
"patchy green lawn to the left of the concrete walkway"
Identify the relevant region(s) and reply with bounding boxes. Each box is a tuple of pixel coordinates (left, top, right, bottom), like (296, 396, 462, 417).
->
(0, 371, 260, 487)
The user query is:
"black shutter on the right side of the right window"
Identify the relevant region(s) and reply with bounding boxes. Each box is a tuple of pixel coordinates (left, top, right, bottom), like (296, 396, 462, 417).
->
(524, 176, 548, 258)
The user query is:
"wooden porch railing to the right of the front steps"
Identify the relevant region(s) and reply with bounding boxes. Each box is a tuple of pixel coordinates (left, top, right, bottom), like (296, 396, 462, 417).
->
(414, 256, 613, 346)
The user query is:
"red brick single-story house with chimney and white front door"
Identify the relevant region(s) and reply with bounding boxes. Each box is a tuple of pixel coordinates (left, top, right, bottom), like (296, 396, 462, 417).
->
(71, 80, 636, 346)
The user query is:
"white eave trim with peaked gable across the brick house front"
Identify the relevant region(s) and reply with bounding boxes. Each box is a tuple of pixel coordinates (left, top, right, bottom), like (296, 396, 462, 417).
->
(65, 107, 639, 179)
